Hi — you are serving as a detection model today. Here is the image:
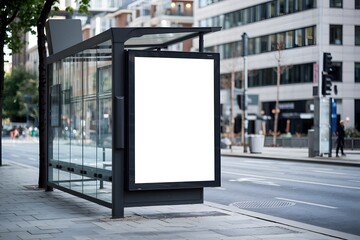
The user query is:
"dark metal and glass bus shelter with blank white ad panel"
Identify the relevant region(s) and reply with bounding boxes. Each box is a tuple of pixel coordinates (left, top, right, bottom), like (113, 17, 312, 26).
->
(47, 27, 220, 217)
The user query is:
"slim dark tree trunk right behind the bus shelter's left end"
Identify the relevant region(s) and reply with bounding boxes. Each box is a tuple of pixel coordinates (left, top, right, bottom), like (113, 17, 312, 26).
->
(37, 0, 55, 188)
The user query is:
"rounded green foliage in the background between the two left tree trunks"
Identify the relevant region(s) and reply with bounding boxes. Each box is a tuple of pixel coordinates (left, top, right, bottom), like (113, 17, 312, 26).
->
(3, 68, 39, 121)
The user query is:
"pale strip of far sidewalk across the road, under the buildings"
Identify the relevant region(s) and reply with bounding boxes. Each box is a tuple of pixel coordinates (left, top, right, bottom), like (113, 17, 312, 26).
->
(221, 146, 360, 167)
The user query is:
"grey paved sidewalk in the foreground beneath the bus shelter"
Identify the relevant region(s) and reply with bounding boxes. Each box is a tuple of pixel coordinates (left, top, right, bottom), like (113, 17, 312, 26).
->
(0, 159, 360, 240)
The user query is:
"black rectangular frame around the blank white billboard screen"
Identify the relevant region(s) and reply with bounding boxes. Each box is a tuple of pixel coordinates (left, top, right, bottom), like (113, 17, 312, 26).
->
(126, 50, 221, 191)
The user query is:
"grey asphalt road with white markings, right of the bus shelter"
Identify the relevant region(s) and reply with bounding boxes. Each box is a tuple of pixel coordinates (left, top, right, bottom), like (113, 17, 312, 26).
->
(205, 157, 360, 235)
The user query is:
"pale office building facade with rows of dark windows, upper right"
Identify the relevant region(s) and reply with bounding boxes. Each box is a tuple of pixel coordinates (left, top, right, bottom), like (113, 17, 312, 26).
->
(194, 0, 360, 134)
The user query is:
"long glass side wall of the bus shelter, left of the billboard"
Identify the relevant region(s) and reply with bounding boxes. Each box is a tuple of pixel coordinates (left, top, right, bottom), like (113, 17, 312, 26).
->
(49, 47, 112, 202)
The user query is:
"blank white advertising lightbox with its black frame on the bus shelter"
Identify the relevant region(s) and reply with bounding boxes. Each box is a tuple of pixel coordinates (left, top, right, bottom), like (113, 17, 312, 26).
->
(128, 50, 220, 190)
